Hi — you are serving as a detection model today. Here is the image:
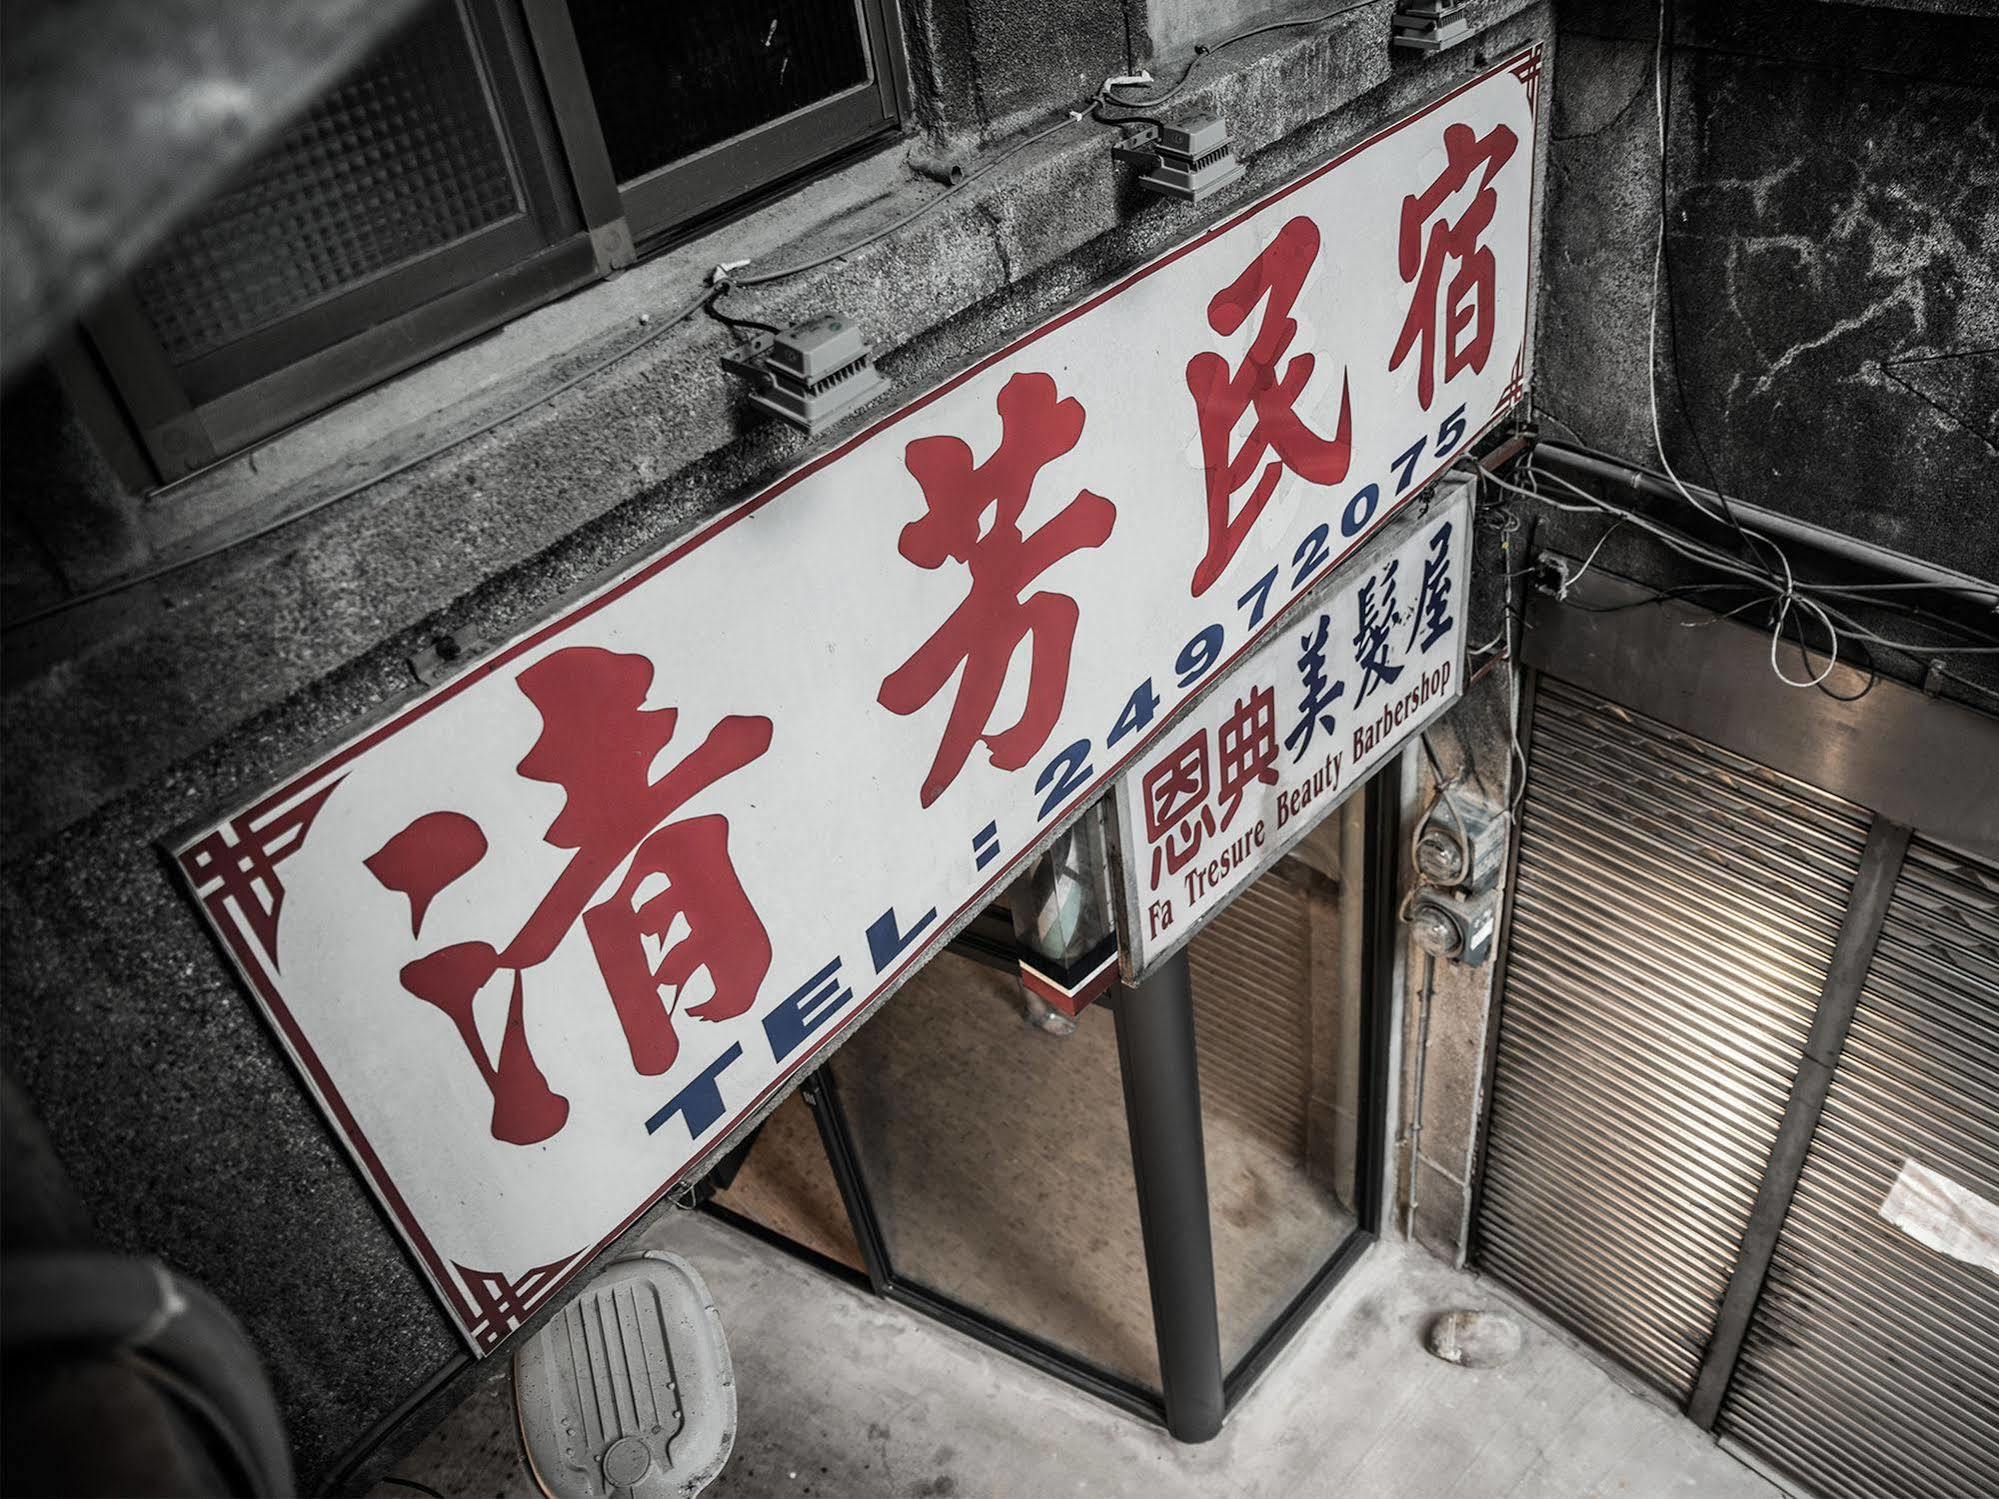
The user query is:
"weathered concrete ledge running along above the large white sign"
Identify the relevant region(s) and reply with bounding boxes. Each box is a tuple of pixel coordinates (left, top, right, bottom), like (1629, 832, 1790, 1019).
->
(4, 0, 1553, 851)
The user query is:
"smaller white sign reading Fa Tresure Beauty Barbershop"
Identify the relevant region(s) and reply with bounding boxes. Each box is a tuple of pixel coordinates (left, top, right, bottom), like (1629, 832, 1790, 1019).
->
(1115, 486, 1471, 983)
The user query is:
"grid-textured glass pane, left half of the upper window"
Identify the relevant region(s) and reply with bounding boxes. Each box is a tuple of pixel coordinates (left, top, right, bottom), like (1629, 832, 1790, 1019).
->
(132, 4, 522, 364)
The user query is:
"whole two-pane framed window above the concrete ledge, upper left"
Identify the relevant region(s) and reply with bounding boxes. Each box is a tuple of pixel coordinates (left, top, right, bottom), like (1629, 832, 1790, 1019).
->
(86, 0, 904, 482)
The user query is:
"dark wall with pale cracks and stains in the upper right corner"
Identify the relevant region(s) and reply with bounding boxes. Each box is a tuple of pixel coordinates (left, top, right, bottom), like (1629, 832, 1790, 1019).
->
(1537, 0, 1999, 578)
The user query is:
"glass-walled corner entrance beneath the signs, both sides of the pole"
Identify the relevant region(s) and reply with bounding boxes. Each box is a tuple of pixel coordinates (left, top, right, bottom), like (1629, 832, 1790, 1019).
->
(704, 785, 1397, 1423)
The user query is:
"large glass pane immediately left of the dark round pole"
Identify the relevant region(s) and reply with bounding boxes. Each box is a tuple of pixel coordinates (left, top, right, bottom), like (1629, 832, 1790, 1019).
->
(832, 953, 1159, 1389)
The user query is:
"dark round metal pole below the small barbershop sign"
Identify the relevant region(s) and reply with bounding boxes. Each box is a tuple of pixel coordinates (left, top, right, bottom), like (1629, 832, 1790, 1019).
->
(1111, 949, 1225, 1441)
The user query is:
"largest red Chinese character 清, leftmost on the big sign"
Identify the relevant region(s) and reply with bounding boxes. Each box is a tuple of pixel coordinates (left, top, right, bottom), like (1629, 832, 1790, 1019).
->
(366, 646, 770, 1145)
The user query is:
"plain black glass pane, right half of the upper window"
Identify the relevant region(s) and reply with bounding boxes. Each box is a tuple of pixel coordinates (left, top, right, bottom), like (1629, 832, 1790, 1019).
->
(570, 0, 868, 182)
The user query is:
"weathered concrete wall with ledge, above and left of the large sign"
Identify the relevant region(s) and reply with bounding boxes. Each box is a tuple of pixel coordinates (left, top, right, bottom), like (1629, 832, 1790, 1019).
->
(0, 0, 1549, 1481)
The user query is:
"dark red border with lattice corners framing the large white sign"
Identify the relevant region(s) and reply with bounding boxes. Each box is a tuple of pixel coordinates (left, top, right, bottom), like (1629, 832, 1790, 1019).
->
(174, 42, 1545, 1353)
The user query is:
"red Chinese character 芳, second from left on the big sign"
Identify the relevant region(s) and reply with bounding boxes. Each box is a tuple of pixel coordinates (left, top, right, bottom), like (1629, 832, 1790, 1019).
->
(878, 374, 1117, 807)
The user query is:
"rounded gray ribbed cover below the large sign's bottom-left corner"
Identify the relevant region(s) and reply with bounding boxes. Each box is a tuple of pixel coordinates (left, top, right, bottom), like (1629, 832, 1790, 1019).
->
(514, 1249, 736, 1499)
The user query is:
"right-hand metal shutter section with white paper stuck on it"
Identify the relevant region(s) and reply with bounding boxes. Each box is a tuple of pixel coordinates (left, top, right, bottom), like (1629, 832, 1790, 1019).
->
(1717, 839, 1999, 1499)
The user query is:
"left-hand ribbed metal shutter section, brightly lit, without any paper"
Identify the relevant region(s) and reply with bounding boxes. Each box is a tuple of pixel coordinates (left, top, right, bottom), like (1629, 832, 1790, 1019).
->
(1477, 678, 1867, 1401)
